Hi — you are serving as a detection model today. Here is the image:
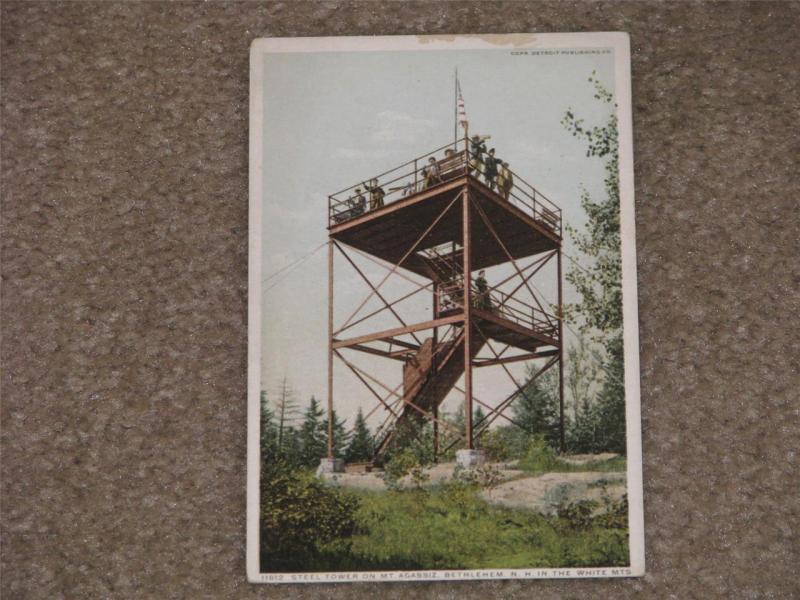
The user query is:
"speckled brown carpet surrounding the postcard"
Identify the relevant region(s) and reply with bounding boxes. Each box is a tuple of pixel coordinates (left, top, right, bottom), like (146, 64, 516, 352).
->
(0, 1, 800, 600)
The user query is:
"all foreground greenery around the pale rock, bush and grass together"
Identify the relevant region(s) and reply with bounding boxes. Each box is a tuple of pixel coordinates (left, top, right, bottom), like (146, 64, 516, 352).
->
(261, 449, 629, 572)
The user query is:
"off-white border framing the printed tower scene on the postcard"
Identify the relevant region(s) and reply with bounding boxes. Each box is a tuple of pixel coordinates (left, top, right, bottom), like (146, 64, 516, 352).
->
(246, 32, 645, 583)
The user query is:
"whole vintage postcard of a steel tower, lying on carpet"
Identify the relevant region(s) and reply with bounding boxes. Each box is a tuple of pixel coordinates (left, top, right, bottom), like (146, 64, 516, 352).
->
(247, 33, 645, 583)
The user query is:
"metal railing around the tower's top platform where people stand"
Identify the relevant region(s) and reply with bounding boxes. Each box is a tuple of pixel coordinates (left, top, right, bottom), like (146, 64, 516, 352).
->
(328, 138, 562, 236)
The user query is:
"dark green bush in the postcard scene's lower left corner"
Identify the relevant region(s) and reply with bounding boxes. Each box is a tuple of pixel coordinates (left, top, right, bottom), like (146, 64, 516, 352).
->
(260, 460, 358, 572)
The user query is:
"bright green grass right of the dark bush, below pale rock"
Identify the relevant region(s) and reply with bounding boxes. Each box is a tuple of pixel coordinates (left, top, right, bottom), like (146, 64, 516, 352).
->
(328, 483, 628, 570)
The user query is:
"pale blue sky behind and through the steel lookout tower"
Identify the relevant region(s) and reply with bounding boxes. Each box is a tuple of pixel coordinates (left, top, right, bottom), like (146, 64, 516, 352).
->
(261, 49, 614, 425)
